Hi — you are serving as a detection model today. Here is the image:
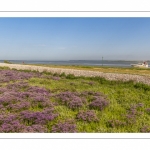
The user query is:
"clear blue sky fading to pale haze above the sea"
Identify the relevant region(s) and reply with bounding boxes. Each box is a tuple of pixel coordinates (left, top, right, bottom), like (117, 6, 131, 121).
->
(0, 17, 150, 60)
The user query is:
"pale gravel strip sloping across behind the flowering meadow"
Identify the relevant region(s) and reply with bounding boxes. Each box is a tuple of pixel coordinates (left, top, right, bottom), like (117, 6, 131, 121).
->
(0, 63, 150, 85)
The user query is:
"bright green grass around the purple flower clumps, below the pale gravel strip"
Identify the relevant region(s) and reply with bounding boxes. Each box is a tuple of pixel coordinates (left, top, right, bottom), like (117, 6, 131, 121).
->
(26, 70, 150, 133)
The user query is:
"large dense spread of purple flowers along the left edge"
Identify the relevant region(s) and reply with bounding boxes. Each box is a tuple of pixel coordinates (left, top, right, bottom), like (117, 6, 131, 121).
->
(0, 70, 58, 133)
